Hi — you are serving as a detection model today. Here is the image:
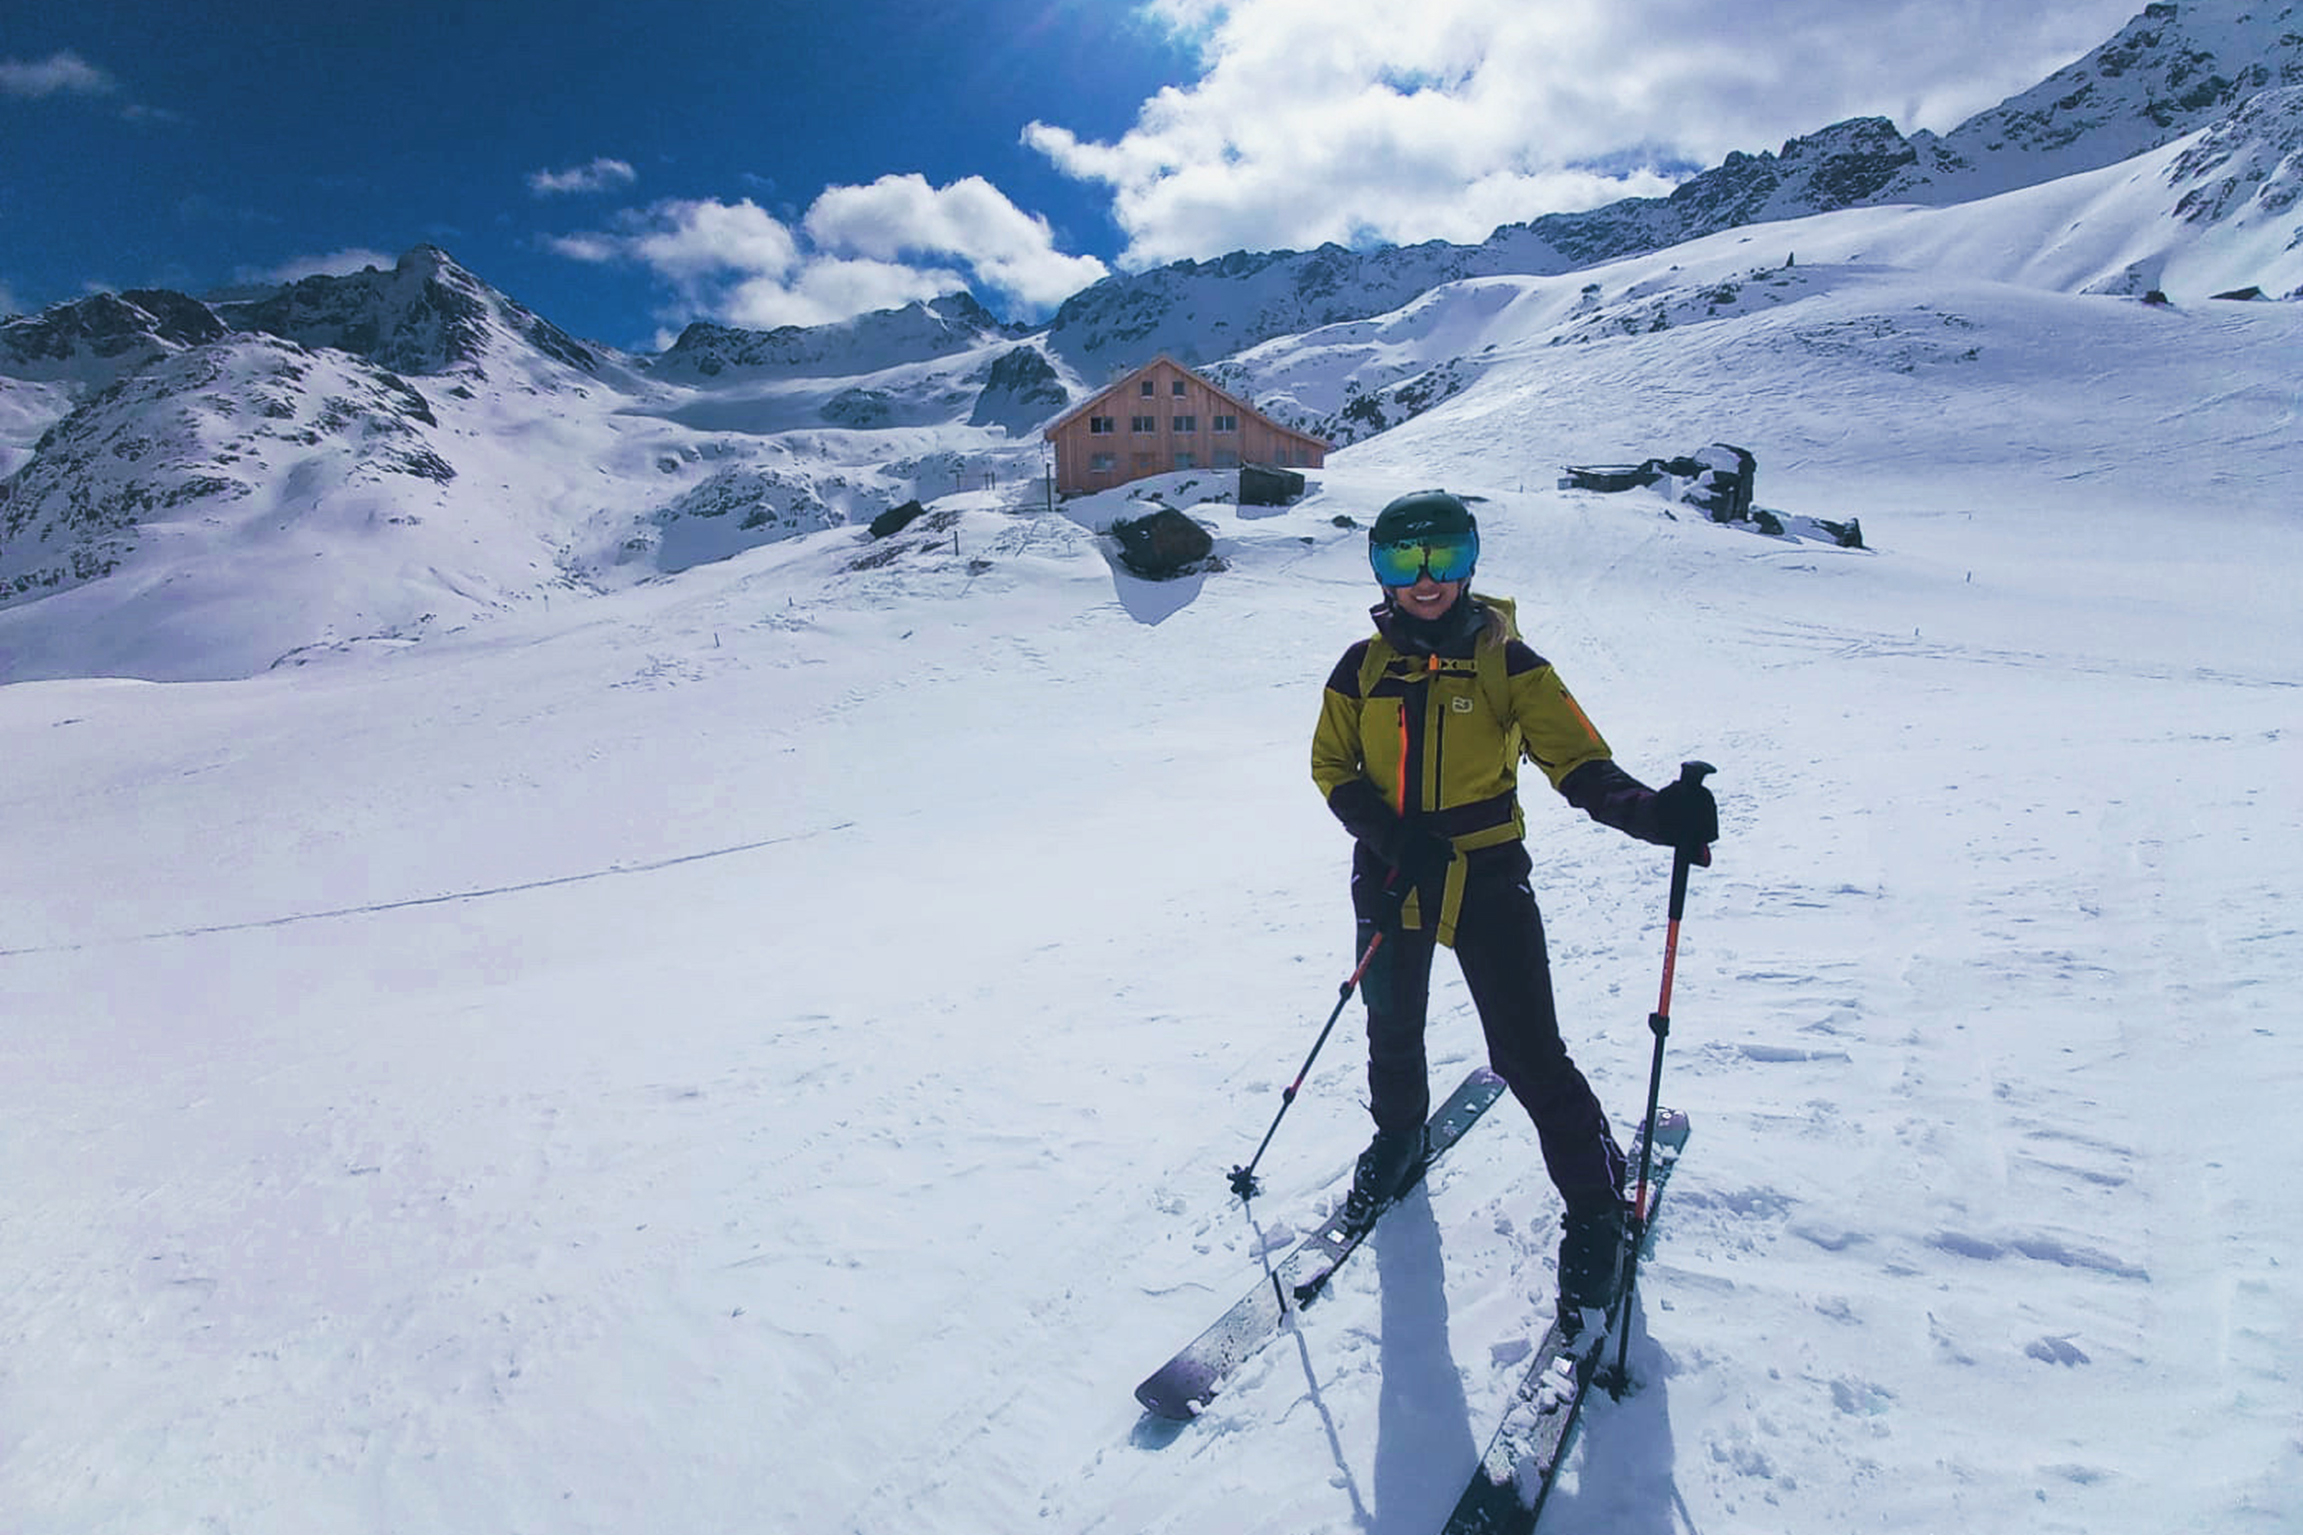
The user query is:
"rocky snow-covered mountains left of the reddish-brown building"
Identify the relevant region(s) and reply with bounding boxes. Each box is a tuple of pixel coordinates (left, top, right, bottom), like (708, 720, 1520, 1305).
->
(0, 246, 1064, 681)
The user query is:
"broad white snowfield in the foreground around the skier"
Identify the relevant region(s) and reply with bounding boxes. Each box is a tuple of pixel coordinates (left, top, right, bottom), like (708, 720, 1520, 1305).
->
(0, 266, 2303, 1535)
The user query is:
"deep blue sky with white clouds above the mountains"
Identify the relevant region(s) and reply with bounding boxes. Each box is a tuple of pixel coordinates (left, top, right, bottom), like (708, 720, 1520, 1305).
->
(0, 0, 2142, 348)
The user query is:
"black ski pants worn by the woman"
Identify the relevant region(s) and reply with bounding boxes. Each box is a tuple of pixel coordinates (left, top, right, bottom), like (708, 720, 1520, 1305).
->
(1352, 842, 1624, 1211)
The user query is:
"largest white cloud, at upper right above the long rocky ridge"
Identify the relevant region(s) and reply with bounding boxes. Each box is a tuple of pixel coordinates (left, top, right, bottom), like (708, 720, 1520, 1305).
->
(1025, 0, 2133, 267)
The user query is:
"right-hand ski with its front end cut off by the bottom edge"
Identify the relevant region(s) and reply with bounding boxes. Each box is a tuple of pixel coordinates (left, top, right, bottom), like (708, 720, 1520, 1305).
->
(1444, 1109, 1688, 1535)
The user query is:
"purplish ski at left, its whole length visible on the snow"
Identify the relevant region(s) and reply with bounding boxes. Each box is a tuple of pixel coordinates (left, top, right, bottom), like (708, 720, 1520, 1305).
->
(1135, 1066, 1504, 1418)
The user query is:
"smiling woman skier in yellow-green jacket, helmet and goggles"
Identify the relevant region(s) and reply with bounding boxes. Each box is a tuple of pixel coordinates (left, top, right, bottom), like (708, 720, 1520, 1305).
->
(1310, 490, 1718, 1316)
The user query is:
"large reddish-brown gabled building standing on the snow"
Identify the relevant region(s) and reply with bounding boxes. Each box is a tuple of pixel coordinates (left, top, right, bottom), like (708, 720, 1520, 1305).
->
(1041, 352, 1329, 495)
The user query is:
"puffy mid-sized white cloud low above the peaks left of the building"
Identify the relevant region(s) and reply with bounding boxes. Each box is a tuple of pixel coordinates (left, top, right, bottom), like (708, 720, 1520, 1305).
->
(550, 175, 1105, 329)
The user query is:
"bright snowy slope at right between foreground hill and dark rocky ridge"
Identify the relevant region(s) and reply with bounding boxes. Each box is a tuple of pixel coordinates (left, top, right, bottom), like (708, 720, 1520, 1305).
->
(1214, 87, 2303, 446)
